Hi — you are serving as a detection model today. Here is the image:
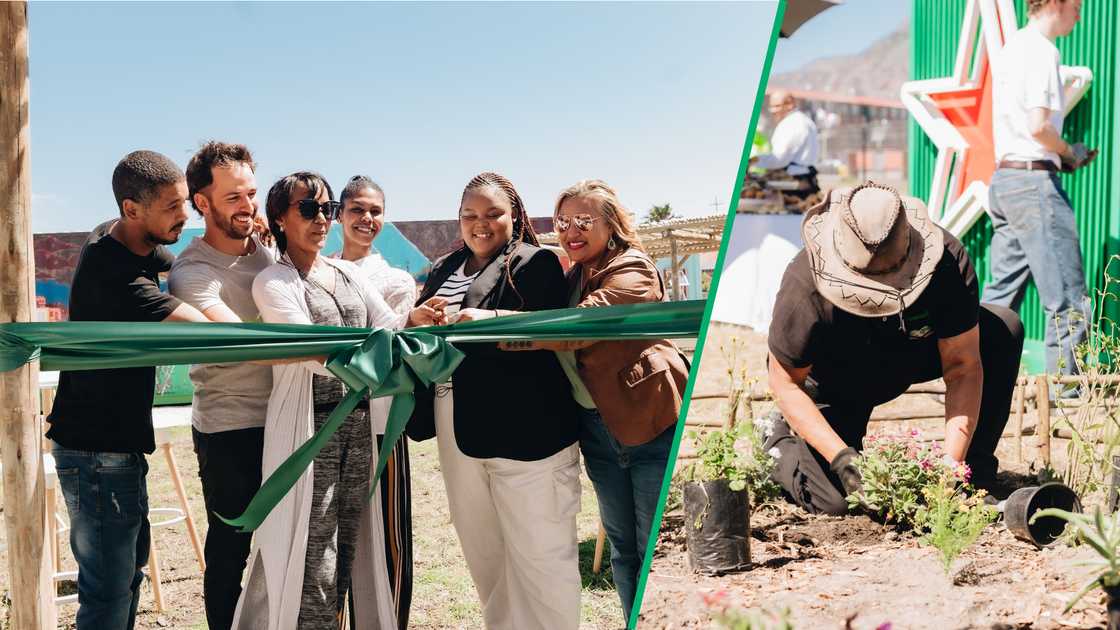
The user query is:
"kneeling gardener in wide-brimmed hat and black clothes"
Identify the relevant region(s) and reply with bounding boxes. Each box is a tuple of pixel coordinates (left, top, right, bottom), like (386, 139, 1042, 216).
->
(765, 184, 1023, 515)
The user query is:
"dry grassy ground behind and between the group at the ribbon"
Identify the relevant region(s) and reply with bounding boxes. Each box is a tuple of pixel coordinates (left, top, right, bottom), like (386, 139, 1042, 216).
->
(0, 408, 623, 630)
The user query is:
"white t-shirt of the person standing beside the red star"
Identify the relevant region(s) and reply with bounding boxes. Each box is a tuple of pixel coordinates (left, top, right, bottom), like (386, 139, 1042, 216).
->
(991, 24, 1065, 166)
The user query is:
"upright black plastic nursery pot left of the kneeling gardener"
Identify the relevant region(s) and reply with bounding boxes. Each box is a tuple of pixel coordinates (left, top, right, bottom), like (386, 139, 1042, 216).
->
(684, 479, 750, 575)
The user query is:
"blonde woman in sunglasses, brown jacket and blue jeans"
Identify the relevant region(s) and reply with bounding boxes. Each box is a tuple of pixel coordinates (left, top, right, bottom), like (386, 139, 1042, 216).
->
(502, 179, 689, 620)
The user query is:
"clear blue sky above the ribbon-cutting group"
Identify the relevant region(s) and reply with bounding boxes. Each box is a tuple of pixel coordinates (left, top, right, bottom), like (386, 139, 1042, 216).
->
(29, 1, 776, 232)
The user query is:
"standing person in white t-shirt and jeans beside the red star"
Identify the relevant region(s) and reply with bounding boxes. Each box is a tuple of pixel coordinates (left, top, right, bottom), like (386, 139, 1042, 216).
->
(982, 0, 1096, 383)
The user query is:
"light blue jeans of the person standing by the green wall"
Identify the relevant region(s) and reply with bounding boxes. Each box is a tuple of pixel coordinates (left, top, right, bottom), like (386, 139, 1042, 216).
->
(983, 168, 1091, 374)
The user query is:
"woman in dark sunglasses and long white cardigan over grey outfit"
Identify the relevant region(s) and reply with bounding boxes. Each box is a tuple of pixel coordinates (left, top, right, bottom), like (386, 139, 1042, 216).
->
(234, 172, 441, 630)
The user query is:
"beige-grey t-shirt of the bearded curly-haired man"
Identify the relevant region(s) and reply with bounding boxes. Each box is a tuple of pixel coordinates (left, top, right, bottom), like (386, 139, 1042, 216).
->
(167, 238, 277, 433)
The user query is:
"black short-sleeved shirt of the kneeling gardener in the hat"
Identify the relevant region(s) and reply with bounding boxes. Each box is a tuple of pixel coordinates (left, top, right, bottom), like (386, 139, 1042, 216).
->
(768, 227, 980, 406)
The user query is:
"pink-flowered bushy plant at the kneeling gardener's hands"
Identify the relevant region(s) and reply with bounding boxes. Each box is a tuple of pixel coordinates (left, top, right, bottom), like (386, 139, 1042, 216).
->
(848, 430, 971, 528)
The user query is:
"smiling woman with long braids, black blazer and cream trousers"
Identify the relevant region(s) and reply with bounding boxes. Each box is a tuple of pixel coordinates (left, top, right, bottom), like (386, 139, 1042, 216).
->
(409, 173, 581, 630)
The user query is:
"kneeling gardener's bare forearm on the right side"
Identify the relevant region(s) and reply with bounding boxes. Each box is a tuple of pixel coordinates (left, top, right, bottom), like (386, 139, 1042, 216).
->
(937, 326, 983, 462)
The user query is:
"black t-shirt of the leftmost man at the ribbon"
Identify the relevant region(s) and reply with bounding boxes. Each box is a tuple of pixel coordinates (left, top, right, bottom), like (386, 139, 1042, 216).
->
(47, 221, 180, 453)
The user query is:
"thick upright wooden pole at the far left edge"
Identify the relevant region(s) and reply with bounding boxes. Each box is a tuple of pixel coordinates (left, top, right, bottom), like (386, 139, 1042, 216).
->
(0, 2, 57, 629)
